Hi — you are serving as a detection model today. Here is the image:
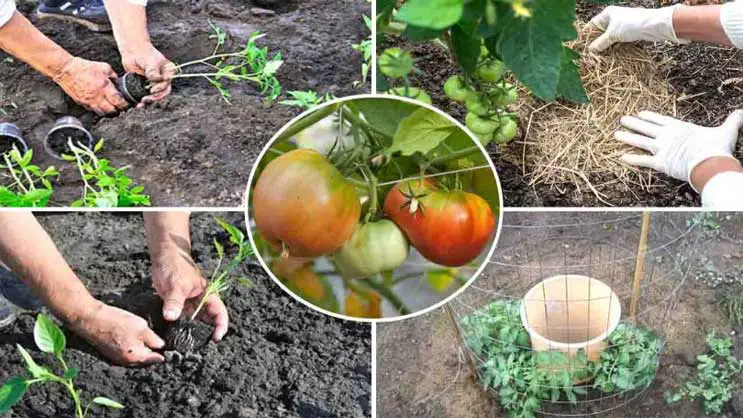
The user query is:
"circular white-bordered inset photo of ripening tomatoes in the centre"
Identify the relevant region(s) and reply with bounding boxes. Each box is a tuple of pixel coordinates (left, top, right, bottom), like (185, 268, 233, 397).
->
(246, 95, 502, 319)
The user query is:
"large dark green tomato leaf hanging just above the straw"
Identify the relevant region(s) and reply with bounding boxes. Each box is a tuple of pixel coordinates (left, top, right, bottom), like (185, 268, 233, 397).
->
(496, 0, 577, 100)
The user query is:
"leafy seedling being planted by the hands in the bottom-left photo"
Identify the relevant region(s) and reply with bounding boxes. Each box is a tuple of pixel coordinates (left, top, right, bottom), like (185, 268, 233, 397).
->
(191, 218, 253, 320)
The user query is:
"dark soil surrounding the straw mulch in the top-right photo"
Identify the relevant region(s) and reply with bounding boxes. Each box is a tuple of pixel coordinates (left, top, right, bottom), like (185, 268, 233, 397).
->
(379, 0, 743, 207)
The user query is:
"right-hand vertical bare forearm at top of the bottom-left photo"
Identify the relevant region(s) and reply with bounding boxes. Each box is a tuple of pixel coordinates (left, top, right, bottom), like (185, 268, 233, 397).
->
(144, 212, 191, 263)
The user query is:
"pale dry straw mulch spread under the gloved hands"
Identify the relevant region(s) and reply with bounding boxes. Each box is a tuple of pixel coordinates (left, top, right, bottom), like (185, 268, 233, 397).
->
(517, 24, 676, 205)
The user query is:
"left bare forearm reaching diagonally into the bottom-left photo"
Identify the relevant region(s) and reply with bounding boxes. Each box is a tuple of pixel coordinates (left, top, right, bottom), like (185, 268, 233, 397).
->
(0, 212, 99, 324)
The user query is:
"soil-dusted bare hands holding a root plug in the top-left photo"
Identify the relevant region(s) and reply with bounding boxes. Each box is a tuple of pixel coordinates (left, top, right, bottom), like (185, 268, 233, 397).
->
(54, 44, 176, 115)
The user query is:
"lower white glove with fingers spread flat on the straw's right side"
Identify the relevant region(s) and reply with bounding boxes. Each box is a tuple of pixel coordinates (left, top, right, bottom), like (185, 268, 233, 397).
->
(614, 110, 743, 191)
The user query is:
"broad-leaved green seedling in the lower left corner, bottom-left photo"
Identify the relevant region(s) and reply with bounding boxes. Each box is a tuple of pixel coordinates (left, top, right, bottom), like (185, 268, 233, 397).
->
(0, 314, 124, 418)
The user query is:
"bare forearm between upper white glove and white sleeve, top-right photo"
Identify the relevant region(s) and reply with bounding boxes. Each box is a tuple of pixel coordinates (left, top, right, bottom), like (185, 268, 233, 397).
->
(673, 5, 732, 46)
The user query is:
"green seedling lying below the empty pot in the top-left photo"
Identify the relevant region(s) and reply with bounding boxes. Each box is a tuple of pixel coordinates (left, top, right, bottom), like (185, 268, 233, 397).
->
(62, 140, 150, 208)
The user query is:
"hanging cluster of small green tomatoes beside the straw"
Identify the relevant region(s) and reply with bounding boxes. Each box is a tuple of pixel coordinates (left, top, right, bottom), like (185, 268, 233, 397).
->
(444, 50, 518, 146)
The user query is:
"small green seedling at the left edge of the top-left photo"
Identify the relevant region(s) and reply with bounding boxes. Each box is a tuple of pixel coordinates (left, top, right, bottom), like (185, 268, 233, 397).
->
(0, 146, 59, 208)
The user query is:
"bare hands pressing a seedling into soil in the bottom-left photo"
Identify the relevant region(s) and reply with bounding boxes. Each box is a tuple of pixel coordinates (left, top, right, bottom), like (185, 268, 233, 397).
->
(73, 254, 229, 365)
